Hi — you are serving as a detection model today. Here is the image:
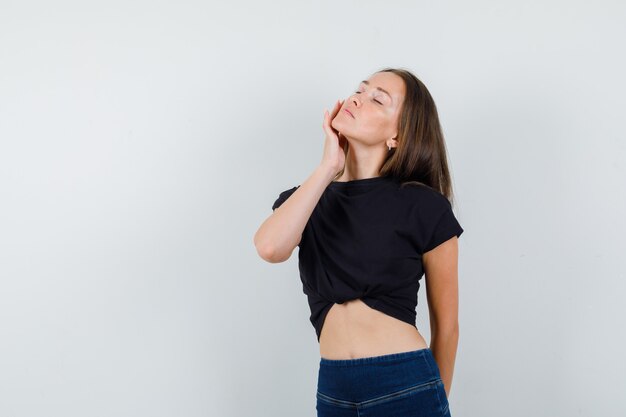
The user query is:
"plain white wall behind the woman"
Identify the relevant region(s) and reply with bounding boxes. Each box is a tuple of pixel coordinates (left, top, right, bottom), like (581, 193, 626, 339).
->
(0, 0, 626, 417)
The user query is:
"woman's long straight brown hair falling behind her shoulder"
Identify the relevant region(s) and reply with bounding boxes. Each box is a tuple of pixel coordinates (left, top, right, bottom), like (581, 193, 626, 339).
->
(336, 68, 453, 208)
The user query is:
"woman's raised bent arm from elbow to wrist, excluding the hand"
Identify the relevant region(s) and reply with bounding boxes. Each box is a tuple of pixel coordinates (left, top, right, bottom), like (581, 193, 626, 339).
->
(254, 165, 335, 263)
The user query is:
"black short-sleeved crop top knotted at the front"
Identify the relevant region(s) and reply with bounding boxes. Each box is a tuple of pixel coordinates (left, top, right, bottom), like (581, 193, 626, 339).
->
(272, 176, 463, 343)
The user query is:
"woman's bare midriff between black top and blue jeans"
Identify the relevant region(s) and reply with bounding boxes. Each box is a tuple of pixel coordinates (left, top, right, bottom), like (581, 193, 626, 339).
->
(320, 299, 428, 359)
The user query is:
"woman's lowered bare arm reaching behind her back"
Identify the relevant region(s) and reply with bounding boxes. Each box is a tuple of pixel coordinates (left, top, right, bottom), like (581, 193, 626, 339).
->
(422, 236, 459, 396)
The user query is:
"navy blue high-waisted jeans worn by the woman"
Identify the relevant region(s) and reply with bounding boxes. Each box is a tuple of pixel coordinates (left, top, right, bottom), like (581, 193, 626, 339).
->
(316, 348, 451, 417)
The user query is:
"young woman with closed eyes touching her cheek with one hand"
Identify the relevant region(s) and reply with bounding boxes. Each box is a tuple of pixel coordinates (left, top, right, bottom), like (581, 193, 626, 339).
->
(254, 68, 463, 416)
